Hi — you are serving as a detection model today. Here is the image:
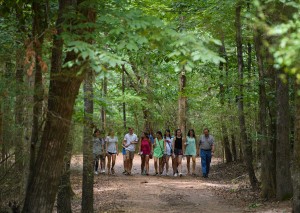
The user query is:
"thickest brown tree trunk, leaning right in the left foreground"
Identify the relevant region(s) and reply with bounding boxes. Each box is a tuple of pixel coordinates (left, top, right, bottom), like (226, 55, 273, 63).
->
(22, 0, 96, 212)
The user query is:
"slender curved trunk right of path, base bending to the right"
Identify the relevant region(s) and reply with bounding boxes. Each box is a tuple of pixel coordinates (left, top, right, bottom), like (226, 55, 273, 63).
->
(235, 1, 257, 188)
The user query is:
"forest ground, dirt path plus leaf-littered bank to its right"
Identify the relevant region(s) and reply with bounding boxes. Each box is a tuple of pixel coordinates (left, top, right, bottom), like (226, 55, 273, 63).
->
(66, 155, 291, 213)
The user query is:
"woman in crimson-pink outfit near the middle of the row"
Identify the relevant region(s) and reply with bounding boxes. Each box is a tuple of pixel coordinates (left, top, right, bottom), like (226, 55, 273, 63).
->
(140, 132, 152, 175)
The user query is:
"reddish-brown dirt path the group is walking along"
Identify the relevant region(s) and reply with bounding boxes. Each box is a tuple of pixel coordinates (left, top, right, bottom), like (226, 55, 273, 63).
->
(72, 155, 244, 213)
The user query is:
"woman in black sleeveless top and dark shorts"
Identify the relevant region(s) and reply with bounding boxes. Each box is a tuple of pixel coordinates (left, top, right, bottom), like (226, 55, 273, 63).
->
(172, 129, 185, 177)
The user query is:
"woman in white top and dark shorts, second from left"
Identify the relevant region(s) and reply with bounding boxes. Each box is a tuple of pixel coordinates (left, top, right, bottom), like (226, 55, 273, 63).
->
(105, 130, 118, 174)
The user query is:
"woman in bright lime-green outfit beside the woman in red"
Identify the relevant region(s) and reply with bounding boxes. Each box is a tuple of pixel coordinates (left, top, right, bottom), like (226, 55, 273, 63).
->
(153, 131, 165, 175)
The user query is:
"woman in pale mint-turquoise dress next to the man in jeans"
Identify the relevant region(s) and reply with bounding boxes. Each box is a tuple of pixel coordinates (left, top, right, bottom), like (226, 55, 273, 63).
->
(184, 129, 197, 175)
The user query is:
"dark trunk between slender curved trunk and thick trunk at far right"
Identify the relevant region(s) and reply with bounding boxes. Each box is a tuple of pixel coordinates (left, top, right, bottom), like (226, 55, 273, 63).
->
(254, 30, 276, 198)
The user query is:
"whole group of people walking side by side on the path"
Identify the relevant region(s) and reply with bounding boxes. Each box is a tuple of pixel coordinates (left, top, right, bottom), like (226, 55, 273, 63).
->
(93, 128, 214, 178)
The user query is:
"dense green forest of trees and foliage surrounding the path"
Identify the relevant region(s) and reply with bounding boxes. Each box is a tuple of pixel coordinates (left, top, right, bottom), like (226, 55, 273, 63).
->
(0, 0, 300, 213)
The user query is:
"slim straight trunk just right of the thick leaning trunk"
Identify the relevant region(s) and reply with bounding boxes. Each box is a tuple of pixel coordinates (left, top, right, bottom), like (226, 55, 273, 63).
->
(81, 70, 94, 213)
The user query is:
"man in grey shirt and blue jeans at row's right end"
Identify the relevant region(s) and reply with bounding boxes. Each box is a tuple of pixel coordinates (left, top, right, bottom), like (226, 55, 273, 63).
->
(199, 128, 215, 178)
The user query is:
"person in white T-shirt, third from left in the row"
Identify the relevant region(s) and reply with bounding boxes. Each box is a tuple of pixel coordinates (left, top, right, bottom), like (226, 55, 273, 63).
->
(123, 127, 138, 175)
